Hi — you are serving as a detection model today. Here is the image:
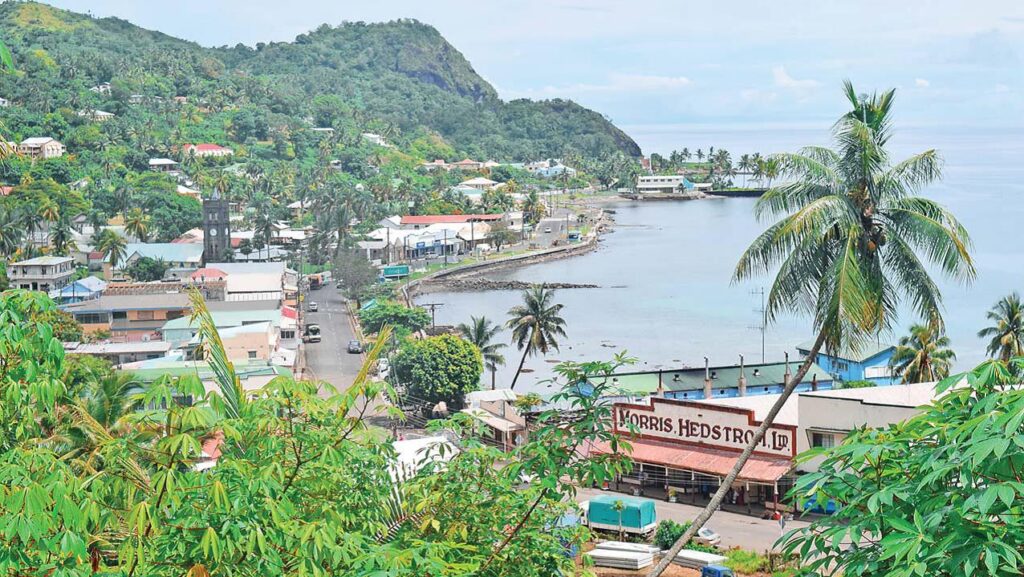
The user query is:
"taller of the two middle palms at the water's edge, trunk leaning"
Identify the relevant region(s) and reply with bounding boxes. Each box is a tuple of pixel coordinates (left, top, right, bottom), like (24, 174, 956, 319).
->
(507, 285, 565, 389)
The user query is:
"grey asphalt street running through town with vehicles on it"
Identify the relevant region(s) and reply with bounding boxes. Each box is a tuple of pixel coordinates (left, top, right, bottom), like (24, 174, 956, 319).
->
(303, 283, 362, 390)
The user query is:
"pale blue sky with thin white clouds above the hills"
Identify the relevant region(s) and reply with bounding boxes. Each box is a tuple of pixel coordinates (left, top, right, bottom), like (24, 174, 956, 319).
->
(37, 0, 1024, 151)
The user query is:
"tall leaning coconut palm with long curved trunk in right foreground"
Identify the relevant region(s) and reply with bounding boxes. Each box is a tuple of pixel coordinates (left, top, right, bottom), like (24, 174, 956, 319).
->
(649, 82, 975, 577)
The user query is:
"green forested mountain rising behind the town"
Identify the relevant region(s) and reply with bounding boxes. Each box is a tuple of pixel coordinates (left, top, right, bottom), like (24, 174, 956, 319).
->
(0, 2, 640, 160)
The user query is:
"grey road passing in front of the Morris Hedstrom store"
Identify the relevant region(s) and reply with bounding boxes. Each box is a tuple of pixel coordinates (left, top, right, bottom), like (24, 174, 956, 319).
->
(577, 489, 809, 552)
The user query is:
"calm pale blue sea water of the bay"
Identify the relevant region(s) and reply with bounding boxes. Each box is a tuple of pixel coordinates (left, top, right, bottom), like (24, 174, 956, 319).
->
(421, 128, 1024, 393)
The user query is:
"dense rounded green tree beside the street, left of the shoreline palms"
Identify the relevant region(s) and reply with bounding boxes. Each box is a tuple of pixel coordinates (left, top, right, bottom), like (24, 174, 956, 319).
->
(394, 334, 483, 407)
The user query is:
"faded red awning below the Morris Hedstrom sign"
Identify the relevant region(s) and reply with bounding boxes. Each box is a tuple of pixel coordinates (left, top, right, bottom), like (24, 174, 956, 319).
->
(591, 439, 793, 484)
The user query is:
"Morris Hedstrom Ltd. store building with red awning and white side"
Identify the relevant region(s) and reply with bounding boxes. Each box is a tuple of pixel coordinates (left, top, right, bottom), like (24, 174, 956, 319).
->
(589, 383, 935, 510)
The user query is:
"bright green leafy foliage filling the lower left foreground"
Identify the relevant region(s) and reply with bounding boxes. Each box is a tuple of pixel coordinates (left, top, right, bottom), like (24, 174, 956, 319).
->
(0, 291, 627, 577)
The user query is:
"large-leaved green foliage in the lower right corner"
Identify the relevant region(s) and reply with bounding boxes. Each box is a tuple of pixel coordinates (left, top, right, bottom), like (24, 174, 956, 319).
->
(783, 358, 1024, 577)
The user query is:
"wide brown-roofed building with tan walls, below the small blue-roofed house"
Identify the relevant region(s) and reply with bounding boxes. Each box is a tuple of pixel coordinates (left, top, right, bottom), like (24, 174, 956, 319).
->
(63, 292, 191, 342)
